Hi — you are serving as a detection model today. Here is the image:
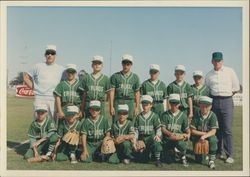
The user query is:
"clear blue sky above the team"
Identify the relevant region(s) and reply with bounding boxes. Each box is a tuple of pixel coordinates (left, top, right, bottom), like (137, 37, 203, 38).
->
(7, 7, 242, 84)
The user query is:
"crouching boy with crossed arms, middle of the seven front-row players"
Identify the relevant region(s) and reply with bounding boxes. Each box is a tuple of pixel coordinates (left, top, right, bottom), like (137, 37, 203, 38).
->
(111, 104, 135, 164)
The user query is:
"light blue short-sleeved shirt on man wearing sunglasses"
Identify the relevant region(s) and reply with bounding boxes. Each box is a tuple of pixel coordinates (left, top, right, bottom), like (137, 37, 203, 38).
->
(28, 62, 65, 100)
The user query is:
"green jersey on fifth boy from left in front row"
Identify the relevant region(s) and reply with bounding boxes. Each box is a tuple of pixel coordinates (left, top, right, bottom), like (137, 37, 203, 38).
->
(134, 111, 161, 139)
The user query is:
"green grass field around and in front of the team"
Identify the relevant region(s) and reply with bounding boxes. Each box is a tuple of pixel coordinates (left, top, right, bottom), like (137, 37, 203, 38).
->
(7, 94, 243, 171)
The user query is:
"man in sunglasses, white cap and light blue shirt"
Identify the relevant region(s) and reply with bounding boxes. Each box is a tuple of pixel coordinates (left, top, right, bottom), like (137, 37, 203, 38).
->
(23, 45, 64, 118)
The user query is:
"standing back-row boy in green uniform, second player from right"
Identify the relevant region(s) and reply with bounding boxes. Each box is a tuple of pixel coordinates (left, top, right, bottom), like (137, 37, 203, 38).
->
(167, 65, 193, 121)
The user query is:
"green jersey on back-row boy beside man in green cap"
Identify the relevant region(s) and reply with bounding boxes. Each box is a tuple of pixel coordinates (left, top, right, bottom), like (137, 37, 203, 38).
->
(191, 84, 210, 107)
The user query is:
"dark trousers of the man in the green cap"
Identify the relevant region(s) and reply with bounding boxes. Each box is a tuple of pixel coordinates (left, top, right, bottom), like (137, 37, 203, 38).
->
(212, 97, 234, 157)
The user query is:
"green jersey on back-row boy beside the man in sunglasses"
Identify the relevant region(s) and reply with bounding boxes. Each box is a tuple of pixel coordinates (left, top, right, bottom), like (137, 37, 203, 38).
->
(54, 80, 82, 106)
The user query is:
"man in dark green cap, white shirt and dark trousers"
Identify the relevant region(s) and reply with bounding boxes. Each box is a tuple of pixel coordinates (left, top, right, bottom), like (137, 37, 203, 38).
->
(205, 52, 240, 163)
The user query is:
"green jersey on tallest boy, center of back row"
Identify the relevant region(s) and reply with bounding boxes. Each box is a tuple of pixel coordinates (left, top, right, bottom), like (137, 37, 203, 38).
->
(110, 71, 140, 99)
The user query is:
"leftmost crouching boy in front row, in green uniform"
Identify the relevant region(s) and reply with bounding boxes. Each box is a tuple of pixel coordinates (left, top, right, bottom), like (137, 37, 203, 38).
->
(24, 104, 58, 160)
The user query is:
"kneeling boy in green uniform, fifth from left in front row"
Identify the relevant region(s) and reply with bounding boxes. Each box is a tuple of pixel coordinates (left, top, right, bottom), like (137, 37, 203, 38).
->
(134, 95, 162, 167)
